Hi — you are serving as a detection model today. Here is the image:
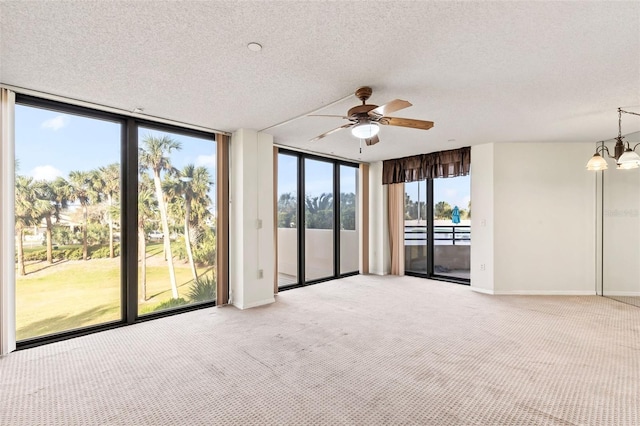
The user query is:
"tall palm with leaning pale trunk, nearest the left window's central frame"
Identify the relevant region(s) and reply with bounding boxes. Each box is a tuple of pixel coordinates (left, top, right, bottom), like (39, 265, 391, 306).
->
(138, 135, 182, 299)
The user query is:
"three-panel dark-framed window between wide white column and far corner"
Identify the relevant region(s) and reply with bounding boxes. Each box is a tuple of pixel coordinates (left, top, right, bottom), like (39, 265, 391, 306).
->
(277, 150, 360, 288)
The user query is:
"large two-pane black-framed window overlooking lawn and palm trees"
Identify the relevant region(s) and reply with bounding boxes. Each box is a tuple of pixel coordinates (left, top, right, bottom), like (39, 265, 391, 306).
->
(15, 95, 218, 347)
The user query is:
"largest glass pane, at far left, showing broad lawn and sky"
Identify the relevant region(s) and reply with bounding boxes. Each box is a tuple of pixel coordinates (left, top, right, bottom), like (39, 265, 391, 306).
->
(15, 105, 121, 340)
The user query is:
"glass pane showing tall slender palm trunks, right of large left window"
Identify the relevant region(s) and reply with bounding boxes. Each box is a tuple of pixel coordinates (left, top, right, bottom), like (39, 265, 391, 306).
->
(138, 128, 216, 315)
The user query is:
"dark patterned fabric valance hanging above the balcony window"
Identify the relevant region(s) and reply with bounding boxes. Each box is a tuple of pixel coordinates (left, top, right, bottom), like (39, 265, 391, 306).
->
(382, 147, 471, 185)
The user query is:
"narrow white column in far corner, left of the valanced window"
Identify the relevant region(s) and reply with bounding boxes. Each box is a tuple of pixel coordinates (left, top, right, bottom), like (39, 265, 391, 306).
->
(369, 161, 391, 275)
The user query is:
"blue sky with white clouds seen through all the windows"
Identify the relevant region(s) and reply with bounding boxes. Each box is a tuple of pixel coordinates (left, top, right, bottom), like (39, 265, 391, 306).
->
(15, 105, 464, 209)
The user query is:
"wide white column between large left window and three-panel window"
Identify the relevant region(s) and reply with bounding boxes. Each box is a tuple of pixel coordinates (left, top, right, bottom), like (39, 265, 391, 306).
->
(229, 129, 275, 309)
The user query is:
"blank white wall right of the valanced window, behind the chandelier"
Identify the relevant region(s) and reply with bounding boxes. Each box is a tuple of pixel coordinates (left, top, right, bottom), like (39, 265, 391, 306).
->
(471, 143, 596, 294)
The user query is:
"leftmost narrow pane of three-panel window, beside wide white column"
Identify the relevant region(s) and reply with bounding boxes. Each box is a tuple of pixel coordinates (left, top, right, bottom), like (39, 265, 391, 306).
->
(278, 154, 298, 287)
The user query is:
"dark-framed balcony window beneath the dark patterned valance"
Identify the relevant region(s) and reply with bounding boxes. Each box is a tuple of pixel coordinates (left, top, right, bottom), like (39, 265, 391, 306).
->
(404, 176, 471, 283)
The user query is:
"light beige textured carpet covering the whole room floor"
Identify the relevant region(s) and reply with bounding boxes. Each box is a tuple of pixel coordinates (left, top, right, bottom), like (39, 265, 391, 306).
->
(0, 276, 640, 425)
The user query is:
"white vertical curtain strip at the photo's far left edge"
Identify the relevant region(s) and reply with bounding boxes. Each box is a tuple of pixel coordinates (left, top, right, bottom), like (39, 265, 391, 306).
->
(0, 88, 16, 355)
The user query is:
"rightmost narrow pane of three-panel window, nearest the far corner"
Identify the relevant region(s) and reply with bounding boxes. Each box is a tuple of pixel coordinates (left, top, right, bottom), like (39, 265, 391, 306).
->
(340, 166, 360, 274)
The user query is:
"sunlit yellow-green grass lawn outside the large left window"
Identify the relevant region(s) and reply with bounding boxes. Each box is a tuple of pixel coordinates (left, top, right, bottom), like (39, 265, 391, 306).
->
(16, 243, 215, 340)
